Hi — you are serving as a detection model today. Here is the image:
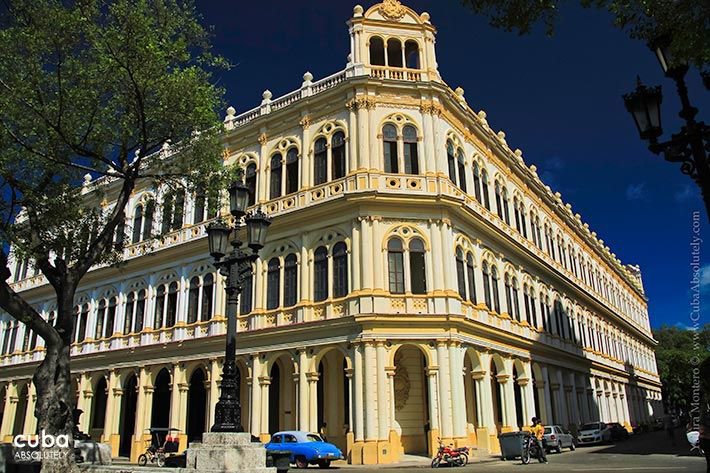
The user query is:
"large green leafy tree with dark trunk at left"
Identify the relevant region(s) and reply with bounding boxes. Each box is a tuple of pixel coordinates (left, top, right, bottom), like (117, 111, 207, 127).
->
(0, 0, 225, 473)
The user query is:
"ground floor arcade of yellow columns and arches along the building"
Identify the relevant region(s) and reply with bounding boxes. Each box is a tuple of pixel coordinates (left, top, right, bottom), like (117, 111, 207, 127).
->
(0, 339, 661, 463)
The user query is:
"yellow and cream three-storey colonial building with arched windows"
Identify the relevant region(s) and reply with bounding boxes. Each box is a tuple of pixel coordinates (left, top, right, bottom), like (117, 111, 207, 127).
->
(0, 0, 662, 464)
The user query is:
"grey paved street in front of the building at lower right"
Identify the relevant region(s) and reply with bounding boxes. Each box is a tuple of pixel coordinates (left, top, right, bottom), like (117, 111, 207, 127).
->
(342, 432, 705, 473)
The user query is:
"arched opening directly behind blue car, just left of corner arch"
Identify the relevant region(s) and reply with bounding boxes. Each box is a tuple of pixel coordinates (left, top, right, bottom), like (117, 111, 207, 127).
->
(316, 348, 350, 451)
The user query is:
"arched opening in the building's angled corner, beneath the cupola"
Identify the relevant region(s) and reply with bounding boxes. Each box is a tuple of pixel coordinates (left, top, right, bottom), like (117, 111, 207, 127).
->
(394, 345, 431, 455)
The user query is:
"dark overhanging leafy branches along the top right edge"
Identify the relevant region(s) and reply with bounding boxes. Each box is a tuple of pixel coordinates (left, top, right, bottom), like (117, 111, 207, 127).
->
(462, 0, 710, 69)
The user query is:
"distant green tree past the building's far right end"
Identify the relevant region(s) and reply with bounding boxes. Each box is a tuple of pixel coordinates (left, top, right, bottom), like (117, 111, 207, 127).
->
(653, 324, 710, 413)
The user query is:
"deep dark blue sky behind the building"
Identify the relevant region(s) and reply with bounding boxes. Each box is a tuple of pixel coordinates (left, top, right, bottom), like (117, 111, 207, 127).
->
(198, 0, 710, 327)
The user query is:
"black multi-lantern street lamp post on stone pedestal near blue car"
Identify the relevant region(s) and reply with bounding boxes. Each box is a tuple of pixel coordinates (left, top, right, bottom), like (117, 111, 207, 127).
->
(207, 182, 271, 432)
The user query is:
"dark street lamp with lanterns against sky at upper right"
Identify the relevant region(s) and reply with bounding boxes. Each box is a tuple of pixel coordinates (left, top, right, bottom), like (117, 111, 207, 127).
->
(624, 38, 710, 218)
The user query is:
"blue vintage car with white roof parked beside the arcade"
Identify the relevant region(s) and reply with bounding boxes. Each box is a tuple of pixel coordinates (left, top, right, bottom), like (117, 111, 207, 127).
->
(266, 430, 344, 468)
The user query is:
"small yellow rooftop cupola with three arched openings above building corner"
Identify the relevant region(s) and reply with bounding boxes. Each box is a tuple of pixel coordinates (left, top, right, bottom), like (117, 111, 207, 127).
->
(348, 0, 441, 81)
